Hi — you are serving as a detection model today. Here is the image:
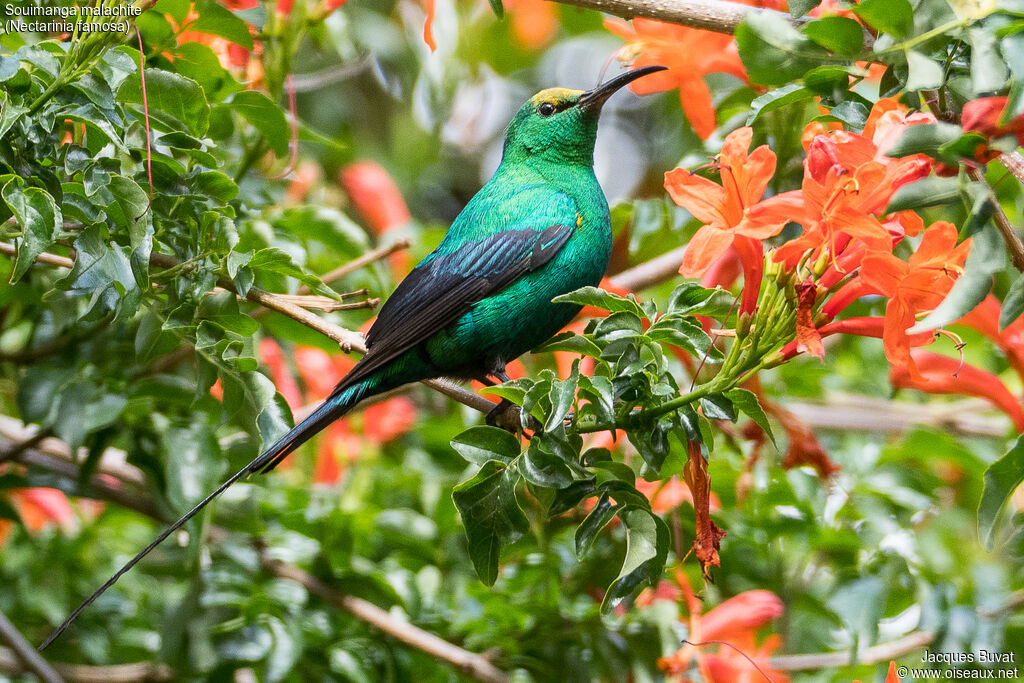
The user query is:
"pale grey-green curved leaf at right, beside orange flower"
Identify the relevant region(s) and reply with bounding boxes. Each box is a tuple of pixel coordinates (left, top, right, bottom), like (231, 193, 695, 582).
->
(906, 226, 1007, 335)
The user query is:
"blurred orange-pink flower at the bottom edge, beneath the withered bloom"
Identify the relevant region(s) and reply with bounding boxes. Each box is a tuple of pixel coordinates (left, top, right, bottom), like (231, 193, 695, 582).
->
(657, 571, 790, 683)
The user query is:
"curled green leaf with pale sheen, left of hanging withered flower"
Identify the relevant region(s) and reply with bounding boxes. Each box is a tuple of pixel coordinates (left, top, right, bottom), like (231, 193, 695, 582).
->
(601, 506, 669, 614)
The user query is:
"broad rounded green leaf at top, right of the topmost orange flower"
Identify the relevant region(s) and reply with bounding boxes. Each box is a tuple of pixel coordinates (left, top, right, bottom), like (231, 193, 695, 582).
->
(735, 11, 831, 86)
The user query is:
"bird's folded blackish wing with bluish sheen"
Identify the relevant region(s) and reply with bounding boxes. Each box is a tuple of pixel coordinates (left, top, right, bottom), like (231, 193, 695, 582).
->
(339, 225, 574, 388)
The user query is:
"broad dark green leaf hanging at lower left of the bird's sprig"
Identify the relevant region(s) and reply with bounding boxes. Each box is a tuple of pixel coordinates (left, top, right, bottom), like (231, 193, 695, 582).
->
(452, 460, 529, 586)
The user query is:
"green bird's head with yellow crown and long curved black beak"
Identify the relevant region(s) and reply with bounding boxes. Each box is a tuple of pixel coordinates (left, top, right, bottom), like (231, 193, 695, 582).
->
(505, 67, 666, 165)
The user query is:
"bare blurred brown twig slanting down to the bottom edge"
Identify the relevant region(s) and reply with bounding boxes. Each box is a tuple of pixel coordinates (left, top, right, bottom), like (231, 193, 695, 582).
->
(260, 551, 509, 683)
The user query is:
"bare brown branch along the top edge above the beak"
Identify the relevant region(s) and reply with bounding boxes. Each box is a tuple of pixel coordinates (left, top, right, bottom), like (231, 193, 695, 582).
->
(544, 0, 792, 34)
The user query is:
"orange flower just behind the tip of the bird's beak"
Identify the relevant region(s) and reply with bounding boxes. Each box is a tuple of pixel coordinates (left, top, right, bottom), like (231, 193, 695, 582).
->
(604, 17, 746, 139)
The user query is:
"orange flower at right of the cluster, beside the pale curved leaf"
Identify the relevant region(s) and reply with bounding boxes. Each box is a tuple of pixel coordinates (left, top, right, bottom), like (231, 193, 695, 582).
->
(860, 221, 971, 380)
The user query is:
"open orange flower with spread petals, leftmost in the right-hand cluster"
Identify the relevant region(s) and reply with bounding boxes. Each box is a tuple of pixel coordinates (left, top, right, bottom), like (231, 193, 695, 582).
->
(665, 128, 785, 311)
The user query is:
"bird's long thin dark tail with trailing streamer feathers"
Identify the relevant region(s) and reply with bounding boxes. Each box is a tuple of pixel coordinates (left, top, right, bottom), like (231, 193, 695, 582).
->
(39, 379, 376, 651)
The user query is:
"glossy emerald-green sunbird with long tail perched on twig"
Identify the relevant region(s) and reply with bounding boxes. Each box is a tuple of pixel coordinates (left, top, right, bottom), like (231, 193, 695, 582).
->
(39, 66, 666, 650)
